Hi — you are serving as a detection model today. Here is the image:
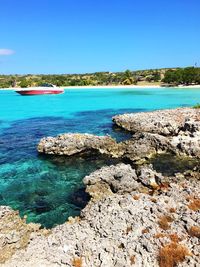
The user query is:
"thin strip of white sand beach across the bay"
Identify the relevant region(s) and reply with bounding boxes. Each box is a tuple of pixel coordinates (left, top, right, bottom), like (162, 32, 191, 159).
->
(0, 85, 200, 91)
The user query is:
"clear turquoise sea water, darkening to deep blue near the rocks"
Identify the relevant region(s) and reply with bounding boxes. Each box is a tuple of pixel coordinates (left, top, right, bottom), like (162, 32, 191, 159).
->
(0, 88, 200, 227)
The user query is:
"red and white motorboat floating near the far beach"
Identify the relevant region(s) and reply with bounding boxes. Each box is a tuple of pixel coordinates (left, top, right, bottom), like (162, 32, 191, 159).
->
(15, 83, 64, 95)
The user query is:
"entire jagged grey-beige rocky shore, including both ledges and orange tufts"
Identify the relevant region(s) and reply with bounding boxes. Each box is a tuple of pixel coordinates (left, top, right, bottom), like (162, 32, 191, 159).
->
(0, 108, 200, 267)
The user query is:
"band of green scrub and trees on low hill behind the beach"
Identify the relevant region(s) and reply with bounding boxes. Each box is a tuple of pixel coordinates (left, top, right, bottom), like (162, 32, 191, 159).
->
(0, 67, 200, 88)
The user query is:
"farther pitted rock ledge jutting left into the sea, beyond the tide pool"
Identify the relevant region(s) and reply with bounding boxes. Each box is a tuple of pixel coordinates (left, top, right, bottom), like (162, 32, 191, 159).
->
(38, 108, 200, 162)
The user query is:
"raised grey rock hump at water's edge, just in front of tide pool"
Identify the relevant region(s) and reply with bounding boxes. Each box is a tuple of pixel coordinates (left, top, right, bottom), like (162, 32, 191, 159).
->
(83, 163, 165, 195)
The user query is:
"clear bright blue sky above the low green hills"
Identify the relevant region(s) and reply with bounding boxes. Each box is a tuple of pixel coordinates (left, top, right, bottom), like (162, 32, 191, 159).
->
(0, 0, 200, 74)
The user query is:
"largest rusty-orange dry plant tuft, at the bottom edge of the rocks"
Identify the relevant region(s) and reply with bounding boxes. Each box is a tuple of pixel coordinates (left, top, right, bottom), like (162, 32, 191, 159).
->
(158, 242, 190, 267)
